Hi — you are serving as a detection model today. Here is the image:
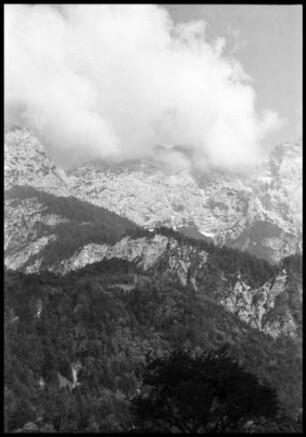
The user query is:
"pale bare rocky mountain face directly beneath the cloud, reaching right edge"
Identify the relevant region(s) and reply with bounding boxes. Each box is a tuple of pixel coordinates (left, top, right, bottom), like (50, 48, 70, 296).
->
(68, 141, 302, 263)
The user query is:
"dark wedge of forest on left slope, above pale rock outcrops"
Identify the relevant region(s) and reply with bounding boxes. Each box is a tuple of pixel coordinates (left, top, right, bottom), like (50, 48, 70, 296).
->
(6, 182, 150, 268)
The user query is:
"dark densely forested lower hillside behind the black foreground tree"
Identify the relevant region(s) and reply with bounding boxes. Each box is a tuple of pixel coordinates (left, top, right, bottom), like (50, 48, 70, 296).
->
(5, 259, 302, 432)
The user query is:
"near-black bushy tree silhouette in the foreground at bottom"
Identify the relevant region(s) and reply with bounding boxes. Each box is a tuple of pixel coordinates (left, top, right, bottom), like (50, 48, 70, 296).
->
(132, 349, 278, 433)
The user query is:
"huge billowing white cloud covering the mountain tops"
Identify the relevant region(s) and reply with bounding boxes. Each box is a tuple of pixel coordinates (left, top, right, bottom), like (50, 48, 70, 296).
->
(5, 5, 280, 167)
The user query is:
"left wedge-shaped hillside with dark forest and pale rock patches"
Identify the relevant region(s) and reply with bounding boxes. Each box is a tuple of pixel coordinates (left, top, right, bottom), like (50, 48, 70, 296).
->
(5, 186, 142, 272)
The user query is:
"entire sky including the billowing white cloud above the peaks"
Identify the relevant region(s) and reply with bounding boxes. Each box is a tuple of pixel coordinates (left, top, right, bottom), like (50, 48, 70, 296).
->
(4, 5, 302, 170)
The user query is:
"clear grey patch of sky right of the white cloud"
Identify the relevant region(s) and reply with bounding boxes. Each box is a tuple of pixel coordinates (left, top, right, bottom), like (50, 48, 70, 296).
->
(165, 5, 303, 143)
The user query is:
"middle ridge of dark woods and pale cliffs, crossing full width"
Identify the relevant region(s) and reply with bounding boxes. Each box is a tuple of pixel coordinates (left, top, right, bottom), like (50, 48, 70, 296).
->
(5, 182, 302, 338)
